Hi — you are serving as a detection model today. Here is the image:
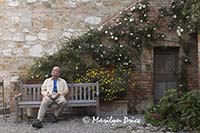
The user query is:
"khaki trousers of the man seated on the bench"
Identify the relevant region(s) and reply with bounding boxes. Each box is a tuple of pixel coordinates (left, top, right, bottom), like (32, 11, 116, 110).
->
(37, 96, 67, 121)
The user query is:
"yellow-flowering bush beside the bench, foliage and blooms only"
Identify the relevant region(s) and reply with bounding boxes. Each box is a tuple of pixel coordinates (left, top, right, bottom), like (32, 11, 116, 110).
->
(75, 69, 134, 101)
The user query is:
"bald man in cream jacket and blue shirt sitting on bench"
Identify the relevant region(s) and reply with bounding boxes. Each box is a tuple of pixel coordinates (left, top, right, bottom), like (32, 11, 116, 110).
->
(32, 66, 69, 128)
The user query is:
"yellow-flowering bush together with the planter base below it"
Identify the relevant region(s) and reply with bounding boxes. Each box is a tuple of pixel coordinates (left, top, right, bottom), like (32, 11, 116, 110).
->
(75, 68, 130, 115)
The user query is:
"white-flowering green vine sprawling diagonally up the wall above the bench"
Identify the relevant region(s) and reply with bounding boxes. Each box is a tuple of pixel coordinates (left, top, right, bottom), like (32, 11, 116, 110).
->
(23, 0, 199, 100)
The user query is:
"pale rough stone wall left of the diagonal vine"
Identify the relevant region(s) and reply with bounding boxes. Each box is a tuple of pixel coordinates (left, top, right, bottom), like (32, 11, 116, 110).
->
(0, 0, 136, 104)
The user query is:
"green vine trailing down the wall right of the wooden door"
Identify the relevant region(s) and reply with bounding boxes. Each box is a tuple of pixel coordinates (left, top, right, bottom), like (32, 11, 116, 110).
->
(167, 0, 200, 91)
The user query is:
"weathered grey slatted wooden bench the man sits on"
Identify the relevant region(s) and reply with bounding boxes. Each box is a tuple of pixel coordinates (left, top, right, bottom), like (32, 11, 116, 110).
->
(15, 83, 100, 122)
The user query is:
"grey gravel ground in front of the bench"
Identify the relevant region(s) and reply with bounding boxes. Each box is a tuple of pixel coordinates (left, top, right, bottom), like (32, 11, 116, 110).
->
(0, 114, 184, 133)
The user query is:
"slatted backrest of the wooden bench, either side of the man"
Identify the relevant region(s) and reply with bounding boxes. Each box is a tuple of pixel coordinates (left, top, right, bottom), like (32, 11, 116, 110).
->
(20, 83, 99, 101)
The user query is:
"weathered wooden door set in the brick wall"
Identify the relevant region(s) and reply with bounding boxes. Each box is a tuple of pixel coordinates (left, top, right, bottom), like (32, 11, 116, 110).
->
(154, 47, 178, 102)
